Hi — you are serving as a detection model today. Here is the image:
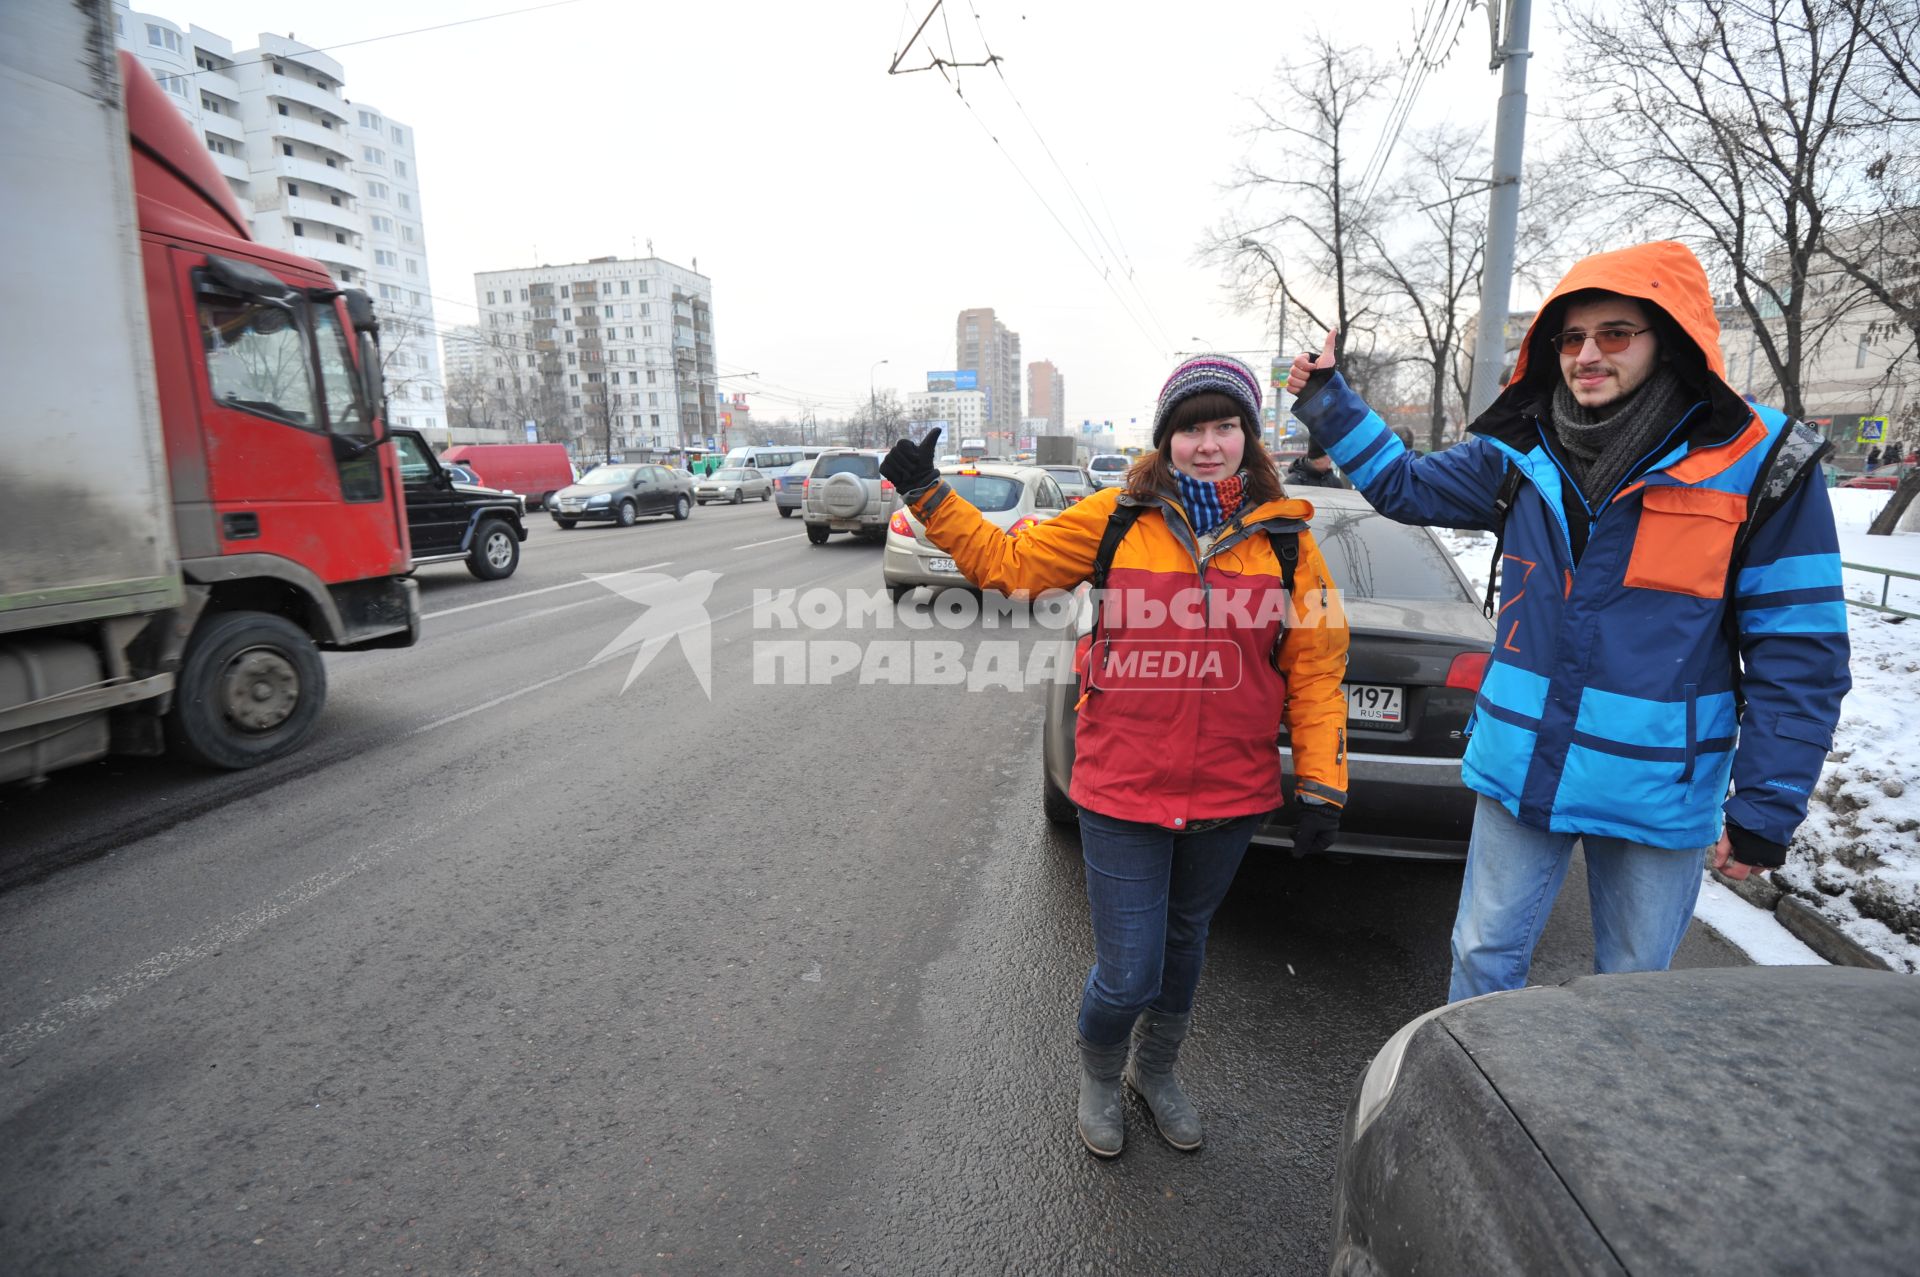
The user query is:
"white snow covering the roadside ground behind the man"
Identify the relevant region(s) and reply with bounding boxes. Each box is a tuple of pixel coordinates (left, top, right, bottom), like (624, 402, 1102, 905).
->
(1438, 488, 1920, 972)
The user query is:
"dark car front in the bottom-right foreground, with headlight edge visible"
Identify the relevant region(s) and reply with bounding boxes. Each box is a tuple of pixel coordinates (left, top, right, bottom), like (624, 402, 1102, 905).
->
(1331, 966, 1920, 1277)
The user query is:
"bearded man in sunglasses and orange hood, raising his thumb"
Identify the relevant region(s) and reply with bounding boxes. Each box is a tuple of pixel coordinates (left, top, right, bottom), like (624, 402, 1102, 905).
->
(1288, 242, 1849, 1000)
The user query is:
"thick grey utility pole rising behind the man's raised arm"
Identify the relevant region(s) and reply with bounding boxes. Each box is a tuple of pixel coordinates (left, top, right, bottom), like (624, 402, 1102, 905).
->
(1467, 0, 1532, 421)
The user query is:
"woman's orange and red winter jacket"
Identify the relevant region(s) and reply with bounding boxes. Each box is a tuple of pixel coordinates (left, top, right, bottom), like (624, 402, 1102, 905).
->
(914, 484, 1348, 830)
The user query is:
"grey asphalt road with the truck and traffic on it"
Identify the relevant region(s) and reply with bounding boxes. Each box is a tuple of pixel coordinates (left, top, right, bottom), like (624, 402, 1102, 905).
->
(0, 505, 1741, 1273)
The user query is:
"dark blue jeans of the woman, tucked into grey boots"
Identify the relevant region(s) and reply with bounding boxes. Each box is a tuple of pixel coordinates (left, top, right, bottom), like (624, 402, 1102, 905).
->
(1079, 810, 1260, 1047)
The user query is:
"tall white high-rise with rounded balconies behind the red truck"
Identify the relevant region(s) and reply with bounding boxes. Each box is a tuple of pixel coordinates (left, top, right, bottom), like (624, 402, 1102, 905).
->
(115, 4, 447, 444)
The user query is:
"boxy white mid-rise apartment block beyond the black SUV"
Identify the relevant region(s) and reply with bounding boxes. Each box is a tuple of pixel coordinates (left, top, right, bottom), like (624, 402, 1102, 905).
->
(474, 257, 732, 459)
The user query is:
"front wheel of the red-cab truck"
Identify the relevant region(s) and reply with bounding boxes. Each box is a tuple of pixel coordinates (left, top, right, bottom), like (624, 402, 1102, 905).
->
(167, 613, 326, 770)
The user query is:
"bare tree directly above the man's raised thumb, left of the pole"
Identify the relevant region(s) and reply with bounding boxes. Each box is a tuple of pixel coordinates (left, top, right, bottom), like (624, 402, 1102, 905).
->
(1200, 35, 1392, 388)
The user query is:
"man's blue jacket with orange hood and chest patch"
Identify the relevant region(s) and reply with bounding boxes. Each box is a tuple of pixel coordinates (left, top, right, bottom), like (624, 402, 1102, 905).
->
(1294, 244, 1849, 864)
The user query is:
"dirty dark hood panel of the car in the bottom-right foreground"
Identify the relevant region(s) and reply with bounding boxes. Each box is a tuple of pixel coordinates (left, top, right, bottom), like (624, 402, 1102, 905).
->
(1436, 966, 1920, 1273)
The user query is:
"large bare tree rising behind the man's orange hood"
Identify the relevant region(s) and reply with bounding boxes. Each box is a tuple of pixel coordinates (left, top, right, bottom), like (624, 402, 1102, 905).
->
(1561, 0, 1870, 417)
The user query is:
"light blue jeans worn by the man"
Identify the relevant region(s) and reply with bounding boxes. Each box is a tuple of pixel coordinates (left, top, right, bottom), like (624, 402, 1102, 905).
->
(1448, 793, 1709, 1002)
